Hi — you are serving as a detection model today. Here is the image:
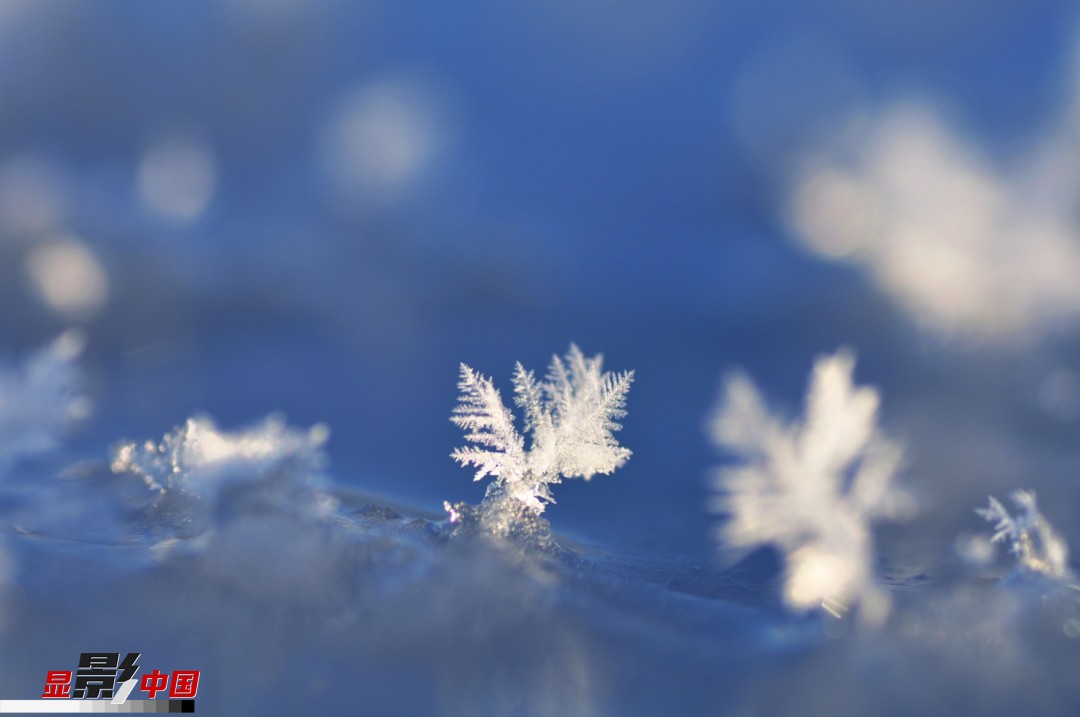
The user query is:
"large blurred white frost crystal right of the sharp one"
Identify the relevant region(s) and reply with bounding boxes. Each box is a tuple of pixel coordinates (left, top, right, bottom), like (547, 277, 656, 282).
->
(711, 351, 908, 623)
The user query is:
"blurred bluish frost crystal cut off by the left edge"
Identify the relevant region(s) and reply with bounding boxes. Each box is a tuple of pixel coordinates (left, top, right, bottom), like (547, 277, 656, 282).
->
(0, 332, 90, 463)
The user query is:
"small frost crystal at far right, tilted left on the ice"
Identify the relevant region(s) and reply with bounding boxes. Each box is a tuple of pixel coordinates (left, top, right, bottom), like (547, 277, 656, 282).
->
(975, 490, 1071, 578)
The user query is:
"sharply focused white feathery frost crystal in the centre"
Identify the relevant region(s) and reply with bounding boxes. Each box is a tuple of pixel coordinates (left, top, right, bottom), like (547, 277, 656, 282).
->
(450, 343, 634, 515)
